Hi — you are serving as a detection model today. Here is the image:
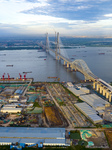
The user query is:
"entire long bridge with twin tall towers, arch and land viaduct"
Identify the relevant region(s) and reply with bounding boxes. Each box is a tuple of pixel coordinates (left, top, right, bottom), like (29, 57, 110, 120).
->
(41, 33, 112, 102)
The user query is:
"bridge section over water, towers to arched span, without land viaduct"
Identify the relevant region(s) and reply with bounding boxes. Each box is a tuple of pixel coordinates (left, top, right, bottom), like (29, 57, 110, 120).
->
(46, 33, 98, 81)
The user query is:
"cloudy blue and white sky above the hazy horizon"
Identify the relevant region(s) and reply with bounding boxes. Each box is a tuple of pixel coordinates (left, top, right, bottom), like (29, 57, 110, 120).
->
(0, 0, 112, 37)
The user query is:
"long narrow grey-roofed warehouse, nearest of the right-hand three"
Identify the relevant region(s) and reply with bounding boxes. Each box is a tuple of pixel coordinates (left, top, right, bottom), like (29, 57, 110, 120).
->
(75, 102, 103, 123)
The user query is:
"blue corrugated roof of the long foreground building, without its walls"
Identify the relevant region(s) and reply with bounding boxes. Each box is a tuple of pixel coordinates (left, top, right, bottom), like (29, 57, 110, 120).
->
(0, 127, 65, 138)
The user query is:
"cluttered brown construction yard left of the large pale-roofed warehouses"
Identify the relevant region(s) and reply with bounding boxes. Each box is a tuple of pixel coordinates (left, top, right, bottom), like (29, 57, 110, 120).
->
(0, 76, 92, 127)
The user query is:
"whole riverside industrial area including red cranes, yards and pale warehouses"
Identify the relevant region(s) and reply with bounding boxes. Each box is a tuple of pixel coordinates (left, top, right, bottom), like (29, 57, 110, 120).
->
(0, 75, 112, 128)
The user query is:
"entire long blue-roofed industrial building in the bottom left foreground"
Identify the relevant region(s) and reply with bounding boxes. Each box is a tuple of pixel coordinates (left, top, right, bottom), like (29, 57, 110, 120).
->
(0, 127, 66, 146)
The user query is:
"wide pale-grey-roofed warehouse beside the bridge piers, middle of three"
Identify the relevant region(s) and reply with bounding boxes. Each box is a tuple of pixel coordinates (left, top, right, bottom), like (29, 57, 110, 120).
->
(79, 94, 110, 111)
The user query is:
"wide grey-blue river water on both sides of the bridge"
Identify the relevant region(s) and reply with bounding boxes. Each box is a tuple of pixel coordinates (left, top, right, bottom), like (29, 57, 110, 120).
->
(0, 47, 112, 82)
